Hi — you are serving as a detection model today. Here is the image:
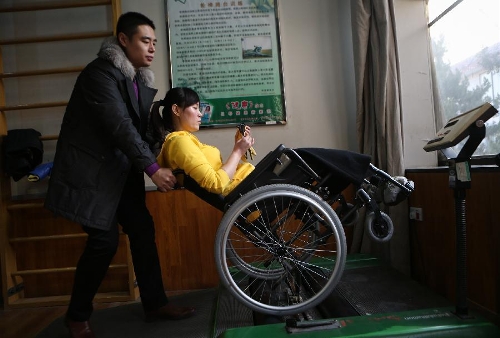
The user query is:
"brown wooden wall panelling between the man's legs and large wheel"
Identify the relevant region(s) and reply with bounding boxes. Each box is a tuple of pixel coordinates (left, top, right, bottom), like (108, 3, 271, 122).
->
(146, 190, 222, 290)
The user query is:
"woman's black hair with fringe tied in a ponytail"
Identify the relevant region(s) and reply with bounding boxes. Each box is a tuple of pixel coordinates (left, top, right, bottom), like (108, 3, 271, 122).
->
(150, 87, 200, 156)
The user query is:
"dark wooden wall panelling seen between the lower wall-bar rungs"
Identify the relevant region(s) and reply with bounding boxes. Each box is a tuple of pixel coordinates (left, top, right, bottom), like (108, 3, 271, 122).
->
(9, 207, 134, 298)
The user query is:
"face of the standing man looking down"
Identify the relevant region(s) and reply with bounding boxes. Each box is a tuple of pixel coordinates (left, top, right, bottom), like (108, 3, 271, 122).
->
(118, 25, 157, 69)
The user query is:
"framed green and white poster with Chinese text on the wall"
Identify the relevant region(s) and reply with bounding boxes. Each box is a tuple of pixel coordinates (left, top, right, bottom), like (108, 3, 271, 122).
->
(165, 0, 286, 128)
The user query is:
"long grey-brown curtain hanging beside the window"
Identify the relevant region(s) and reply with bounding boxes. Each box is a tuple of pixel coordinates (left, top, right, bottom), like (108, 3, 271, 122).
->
(351, 0, 410, 274)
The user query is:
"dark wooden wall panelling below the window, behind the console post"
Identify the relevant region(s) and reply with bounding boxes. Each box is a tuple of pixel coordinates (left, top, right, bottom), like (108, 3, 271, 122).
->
(407, 168, 500, 320)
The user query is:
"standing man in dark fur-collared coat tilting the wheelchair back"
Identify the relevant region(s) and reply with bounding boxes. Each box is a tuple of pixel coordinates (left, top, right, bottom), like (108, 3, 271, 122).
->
(45, 12, 194, 337)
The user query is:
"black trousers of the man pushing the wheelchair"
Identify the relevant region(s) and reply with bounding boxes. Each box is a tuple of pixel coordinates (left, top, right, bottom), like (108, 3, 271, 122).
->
(67, 173, 168, 321)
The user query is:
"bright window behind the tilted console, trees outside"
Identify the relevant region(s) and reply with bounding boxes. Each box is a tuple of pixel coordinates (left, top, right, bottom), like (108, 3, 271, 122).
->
(427, 0, 500, 156)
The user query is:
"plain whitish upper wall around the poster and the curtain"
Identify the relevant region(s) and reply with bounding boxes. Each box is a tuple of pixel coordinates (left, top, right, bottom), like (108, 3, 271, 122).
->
(122, 0, 437, 168)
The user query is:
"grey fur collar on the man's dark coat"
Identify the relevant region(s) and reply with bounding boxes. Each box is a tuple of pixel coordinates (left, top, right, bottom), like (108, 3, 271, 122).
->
(97, 36, 154, 88)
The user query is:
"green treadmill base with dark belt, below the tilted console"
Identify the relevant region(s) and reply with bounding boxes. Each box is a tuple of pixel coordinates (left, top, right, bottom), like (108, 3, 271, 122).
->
(218, 254, 500, 338)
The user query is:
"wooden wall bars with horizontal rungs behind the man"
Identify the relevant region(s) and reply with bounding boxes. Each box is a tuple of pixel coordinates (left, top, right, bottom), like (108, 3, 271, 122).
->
(0, 0, 138, 308)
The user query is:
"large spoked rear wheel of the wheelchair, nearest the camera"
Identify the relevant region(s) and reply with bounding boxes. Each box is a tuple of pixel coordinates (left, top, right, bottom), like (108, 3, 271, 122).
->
(215, 184, 347, 315)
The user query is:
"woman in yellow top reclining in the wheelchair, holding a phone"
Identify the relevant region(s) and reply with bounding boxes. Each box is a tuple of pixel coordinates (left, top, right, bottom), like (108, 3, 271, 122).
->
(151, 87, 255, 196)
